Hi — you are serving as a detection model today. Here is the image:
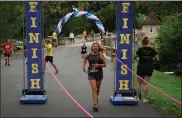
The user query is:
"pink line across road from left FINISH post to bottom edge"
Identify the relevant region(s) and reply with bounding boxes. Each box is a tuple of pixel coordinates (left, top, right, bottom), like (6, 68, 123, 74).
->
(47, 65, 94, 118)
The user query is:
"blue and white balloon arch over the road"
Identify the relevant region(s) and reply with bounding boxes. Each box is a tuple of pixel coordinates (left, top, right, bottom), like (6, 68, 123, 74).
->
(56, 10, 105, 34)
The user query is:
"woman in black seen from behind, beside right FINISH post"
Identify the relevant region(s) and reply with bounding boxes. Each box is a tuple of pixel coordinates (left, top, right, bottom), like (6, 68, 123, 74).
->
(136, 37, 159, 103)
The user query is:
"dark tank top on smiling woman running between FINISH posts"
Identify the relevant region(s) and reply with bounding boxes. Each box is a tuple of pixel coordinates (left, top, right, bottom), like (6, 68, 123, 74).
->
(88, 52, 103, 78)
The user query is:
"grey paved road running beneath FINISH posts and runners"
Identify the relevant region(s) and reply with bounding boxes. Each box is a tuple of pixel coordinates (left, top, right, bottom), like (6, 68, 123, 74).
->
(1, 42, 162, 117)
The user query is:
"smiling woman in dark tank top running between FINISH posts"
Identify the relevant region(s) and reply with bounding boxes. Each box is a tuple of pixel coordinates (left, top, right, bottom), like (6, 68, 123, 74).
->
(83, 42, 106, 111)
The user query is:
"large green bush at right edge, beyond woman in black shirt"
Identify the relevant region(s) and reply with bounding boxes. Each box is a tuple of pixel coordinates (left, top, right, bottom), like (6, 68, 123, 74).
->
(159, 14, 182, 74)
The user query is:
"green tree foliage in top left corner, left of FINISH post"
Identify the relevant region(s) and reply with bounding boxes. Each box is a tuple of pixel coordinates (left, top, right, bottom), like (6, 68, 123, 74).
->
(0, 2, 25, 43)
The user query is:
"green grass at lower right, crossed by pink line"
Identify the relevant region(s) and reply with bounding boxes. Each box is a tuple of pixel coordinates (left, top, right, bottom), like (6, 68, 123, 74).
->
(134, 60, 182, 118)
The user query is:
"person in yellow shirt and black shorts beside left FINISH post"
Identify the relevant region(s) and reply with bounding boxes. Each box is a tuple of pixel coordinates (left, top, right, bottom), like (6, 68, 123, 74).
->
(44, 40, 59, 74)
